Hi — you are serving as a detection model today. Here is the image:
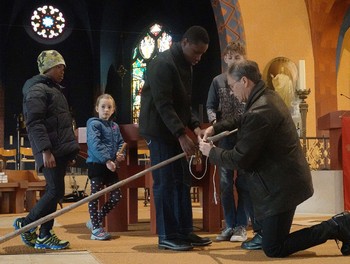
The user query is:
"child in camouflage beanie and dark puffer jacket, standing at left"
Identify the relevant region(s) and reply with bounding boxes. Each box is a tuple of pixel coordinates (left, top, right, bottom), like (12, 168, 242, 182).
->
(13, 50, 79, 250)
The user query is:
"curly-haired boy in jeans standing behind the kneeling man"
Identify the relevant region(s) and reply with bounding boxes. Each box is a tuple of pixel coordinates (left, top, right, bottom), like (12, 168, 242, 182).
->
(207, 41, 249, 242)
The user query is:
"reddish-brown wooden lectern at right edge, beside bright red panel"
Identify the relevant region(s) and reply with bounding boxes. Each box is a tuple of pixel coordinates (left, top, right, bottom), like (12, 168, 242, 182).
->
(317, 110, 350, 170)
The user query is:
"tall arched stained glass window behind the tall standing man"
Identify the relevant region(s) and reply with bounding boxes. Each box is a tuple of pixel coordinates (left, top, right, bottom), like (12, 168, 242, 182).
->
(131, 24, 172, 123)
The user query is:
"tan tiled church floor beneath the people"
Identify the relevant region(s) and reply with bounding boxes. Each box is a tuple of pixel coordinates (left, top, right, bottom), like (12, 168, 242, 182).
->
(0, 177, 348, 264)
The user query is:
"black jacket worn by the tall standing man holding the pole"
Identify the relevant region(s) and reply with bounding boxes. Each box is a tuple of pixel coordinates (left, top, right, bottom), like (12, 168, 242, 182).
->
(139, 43, 199, 141)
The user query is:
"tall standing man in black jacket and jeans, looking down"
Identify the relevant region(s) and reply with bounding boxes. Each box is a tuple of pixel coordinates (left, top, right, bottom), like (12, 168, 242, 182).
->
(139, 26, 211, 251)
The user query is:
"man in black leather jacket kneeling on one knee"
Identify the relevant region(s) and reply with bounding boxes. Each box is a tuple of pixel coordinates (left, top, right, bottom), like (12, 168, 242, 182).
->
(200, 60, 350, 257)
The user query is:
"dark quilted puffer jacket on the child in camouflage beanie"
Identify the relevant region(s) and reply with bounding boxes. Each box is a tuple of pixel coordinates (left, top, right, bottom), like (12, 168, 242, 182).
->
(22, 75, 79, 169)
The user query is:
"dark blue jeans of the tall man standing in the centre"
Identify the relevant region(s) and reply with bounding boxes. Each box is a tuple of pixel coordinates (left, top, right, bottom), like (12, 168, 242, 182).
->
(147, 139, 193, 240)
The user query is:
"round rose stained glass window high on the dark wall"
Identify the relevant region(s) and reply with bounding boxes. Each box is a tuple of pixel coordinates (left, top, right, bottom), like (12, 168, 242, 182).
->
(30, 5, 66, 39)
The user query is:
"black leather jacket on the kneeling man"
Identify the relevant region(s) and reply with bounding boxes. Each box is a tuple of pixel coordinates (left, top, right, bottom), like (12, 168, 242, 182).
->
(209, 81, 313, 219)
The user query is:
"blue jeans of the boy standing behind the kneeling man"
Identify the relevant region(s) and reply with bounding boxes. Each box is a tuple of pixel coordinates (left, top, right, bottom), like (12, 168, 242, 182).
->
(219, 135, 249, 228)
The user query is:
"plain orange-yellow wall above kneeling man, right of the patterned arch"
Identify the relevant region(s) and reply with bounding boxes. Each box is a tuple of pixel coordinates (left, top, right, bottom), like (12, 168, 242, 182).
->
(239, 0, 316, 136)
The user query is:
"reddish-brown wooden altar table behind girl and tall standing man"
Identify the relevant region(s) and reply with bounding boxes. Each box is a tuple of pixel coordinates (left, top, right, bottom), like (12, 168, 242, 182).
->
(80, 124, 221, 234)
